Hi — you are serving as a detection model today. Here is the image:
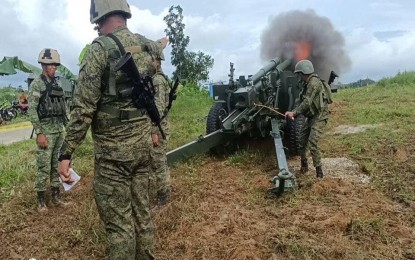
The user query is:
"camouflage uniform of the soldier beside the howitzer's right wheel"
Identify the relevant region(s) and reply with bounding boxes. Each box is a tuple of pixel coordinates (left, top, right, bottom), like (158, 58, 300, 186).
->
(293, 74, 329, 167)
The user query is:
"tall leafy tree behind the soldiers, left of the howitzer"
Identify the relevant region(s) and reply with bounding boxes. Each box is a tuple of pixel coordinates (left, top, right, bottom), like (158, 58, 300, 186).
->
(164, 5, 214, 83)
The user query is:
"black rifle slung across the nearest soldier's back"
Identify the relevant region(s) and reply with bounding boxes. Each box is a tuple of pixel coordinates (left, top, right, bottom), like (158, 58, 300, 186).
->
(114, 52, 166, 139)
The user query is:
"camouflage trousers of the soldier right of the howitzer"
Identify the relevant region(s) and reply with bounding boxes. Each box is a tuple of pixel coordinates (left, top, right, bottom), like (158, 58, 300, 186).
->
(299, 117, 327, 167)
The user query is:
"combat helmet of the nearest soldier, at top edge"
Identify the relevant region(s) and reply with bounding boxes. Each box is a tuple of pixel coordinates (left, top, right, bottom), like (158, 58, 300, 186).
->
(89, 0, 131, 24)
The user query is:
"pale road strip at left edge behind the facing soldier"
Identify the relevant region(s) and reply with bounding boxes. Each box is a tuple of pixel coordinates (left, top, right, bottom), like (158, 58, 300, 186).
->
(0, 122, 32, 144)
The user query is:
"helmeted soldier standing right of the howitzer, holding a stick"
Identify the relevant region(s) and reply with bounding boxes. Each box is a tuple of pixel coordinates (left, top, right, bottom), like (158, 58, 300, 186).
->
(285, 60, 329, 178)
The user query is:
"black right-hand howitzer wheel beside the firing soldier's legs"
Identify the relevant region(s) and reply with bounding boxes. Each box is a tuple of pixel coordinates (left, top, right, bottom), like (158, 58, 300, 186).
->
(284, 115, 305, 156)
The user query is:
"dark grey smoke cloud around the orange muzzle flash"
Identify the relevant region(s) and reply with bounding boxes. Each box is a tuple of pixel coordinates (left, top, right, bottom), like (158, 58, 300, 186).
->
(261, 10, 351, 80)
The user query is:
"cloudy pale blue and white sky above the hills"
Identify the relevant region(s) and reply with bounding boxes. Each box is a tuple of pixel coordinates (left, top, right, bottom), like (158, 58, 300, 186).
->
(0, 0, 415, 86)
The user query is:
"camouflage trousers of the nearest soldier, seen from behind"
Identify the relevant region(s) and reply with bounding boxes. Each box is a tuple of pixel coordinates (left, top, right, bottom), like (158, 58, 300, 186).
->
(94, 149, 154, 260)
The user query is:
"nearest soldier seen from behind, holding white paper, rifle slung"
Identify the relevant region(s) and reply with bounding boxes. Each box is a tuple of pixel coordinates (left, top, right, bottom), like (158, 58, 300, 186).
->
(59, 0, 168, 260)
